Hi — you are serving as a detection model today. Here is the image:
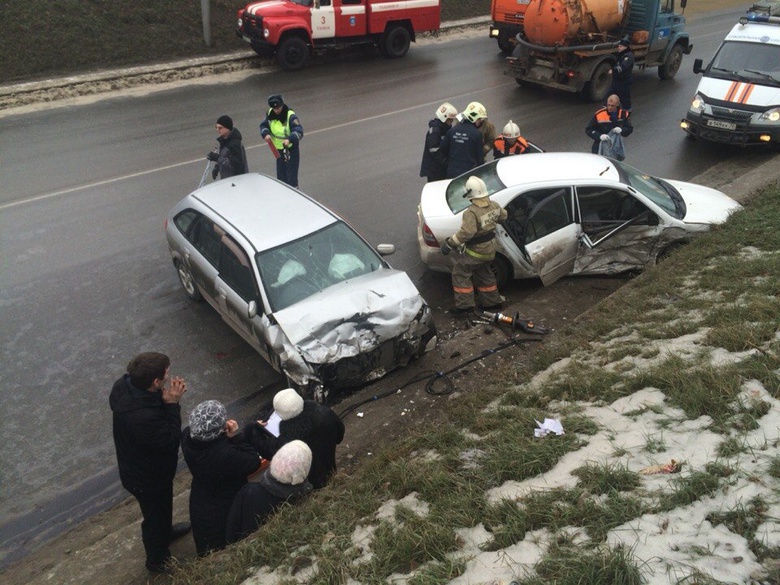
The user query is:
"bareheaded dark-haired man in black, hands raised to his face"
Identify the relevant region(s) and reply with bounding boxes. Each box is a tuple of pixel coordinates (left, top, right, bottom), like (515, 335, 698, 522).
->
(109, 352, 190, 573)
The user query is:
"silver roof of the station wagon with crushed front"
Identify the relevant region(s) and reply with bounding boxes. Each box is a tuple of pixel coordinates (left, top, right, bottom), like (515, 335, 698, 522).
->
(189, 173, 338, 252)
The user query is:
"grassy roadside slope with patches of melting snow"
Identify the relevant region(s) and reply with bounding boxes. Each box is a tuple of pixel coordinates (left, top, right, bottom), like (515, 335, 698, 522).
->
(173, 185, 780, 585)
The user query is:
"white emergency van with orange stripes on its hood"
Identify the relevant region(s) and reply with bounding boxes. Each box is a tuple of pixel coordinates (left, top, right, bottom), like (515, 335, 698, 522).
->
(680, 0, 780, 148)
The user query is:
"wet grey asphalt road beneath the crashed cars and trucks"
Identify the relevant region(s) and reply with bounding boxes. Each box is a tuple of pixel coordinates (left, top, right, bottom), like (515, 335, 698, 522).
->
(0, 4, 767, 564)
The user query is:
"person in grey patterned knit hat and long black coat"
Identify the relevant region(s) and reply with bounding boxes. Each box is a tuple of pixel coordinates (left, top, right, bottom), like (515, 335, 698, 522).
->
(181, 400, 262, 556)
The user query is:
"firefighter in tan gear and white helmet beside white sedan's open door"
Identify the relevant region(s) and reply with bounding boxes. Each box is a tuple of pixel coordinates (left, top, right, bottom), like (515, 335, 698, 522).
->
(441, 176, 507, 314)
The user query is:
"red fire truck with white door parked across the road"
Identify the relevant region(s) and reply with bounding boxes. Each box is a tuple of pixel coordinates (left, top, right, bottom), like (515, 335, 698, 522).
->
(236, 0, 441, 71)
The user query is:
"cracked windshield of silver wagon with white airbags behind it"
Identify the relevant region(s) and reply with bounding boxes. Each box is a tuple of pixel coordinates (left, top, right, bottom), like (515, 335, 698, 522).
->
(256, 221, 384, 311)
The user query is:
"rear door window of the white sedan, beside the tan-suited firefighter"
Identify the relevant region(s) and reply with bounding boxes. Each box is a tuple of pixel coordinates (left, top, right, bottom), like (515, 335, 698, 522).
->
(504, 187, 574, 246)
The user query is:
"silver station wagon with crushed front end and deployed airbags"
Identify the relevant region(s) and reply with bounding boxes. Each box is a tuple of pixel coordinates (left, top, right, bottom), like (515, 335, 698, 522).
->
(165, 173, 436, 400)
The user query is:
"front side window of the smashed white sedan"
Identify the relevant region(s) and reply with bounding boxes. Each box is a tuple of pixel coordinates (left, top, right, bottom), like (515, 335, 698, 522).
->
(577, 186, 657, 244)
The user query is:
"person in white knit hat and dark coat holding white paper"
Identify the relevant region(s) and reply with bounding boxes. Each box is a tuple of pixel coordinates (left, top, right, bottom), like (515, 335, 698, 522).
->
(247, 388, 344, 489)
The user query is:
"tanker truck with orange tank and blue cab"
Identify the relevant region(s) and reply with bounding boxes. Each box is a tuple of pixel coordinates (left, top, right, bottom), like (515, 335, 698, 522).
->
(506, 0, 693, 102)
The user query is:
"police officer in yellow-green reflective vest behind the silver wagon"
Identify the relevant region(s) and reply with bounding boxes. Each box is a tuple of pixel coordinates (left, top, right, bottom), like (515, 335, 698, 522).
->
(260, 94, 303, 189)
